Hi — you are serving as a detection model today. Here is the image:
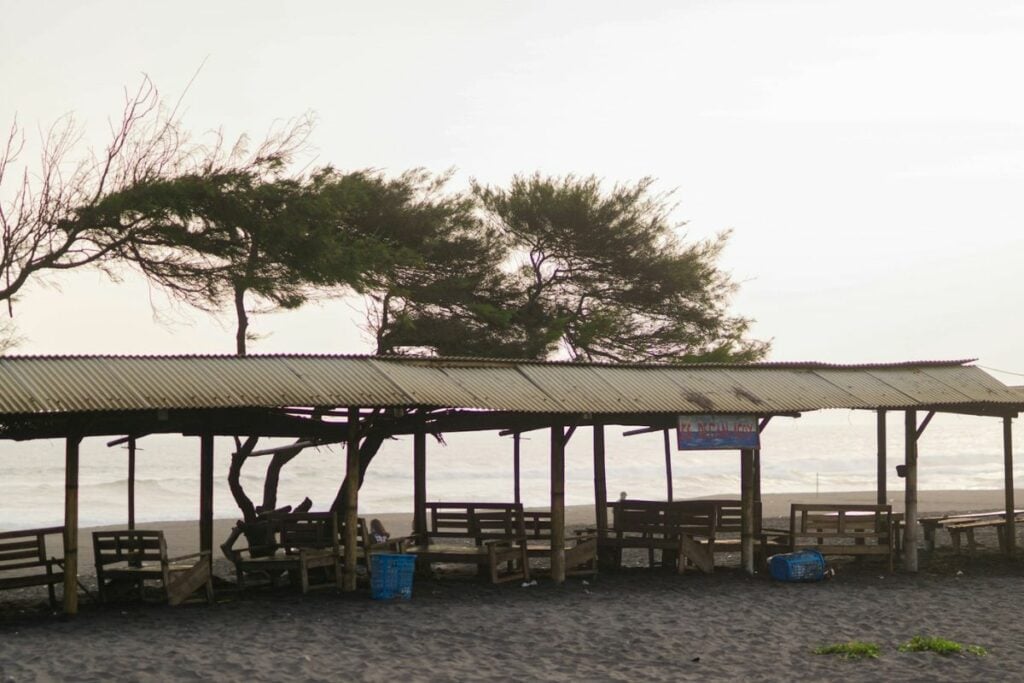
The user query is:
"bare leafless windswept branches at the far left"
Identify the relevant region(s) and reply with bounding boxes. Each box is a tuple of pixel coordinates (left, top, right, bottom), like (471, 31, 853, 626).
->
(0, 79, 212, 312)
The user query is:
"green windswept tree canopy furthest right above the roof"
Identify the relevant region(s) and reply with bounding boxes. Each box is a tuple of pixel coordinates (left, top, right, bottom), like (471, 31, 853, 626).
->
(473, 174, 767, 361)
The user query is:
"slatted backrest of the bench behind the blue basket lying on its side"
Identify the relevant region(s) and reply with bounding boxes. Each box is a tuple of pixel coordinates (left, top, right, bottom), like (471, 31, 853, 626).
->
(790, 503, 893, 545)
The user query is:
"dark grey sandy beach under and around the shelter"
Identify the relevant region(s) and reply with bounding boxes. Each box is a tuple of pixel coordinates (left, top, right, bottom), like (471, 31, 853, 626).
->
(0, 492, 1024, 682)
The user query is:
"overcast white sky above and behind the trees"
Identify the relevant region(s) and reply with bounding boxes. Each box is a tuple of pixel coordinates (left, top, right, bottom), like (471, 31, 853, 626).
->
(0, 0, 1024, 376)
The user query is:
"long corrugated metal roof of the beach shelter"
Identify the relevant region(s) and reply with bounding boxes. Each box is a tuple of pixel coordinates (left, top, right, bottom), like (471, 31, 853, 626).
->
(0, 355, 1024, 415)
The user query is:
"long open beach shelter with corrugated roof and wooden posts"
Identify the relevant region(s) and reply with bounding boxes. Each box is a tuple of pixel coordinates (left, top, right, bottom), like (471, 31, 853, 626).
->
(0, 355, 1024, 613)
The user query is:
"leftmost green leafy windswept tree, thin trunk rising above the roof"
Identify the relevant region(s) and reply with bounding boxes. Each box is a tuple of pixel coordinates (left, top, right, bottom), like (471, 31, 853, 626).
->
(110, 162, 383, 354)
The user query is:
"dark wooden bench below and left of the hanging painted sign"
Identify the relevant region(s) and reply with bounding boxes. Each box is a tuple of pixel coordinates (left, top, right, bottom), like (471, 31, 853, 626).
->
(598, 500, 716, 573)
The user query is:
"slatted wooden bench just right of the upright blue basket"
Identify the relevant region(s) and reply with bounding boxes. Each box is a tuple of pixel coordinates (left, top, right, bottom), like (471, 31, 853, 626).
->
(404, 503, 529, 584)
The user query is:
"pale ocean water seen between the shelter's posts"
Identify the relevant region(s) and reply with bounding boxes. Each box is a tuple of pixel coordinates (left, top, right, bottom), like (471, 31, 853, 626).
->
(0, 411, 1024, 529)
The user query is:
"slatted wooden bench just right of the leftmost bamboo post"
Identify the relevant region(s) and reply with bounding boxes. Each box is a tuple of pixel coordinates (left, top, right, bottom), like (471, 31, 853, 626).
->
(92, 529, 213, 605)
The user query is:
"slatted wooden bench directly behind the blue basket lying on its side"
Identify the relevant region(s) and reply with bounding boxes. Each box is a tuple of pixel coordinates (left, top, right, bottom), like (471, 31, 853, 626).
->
(765, 503, 895, 571)
